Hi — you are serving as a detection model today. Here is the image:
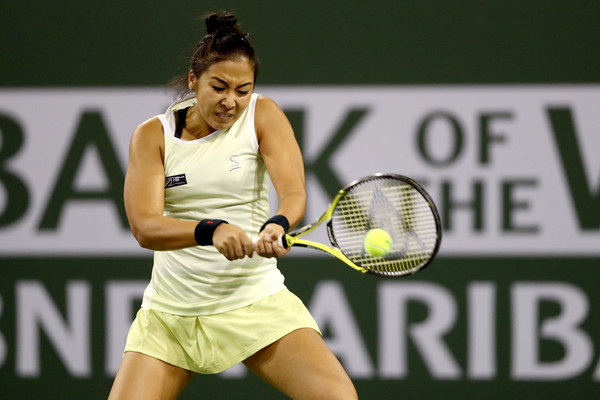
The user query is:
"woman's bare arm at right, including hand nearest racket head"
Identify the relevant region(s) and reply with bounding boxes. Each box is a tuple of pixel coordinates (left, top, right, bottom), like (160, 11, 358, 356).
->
(254, 96, 306, 257)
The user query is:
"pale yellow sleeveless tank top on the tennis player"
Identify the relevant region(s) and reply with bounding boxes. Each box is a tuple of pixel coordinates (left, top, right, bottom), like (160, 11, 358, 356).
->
(142, 93, 285, 315)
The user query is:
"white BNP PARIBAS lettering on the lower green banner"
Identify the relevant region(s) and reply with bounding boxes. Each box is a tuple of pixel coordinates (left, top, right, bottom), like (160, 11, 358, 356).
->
(0, 280, 600, 382)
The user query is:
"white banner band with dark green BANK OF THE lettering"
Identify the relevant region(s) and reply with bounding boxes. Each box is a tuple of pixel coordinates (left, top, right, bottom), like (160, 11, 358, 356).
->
(0, 85, 600, 256)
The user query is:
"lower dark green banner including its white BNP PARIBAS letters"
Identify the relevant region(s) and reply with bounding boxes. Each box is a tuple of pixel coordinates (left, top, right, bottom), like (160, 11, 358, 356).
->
(0, 258, 600, 399)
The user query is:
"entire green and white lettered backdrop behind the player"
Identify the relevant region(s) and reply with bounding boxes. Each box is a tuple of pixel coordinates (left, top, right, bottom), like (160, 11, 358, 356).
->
(0, 0, 600, 400)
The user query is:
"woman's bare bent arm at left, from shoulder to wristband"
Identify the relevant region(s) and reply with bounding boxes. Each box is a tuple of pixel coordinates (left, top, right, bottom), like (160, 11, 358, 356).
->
(124, 118, 198, 250)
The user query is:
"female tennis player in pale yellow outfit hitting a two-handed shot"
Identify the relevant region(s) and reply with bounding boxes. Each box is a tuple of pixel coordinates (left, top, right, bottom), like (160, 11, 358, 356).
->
(109, 13, 357, 400)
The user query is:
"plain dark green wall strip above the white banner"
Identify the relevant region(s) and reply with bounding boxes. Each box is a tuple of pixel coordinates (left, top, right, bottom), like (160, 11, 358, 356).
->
(0, 0, 600, 86)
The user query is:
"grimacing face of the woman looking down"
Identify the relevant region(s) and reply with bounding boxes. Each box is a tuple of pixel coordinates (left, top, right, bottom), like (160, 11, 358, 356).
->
(189, 58, 254, 132)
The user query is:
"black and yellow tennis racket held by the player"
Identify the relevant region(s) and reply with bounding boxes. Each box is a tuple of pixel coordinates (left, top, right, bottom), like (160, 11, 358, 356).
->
(279, 173, 442, 277)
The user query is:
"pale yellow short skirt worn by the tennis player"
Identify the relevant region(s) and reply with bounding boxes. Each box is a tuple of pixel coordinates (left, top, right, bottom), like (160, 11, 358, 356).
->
(125, 289, 321, 374)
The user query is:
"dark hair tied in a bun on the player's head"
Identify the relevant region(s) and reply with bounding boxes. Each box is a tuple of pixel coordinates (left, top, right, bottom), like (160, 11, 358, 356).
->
(172, 12, 258, 97)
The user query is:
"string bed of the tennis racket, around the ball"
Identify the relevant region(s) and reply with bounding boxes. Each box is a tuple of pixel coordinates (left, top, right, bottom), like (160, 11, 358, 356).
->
(331, 179, 437, 275)
